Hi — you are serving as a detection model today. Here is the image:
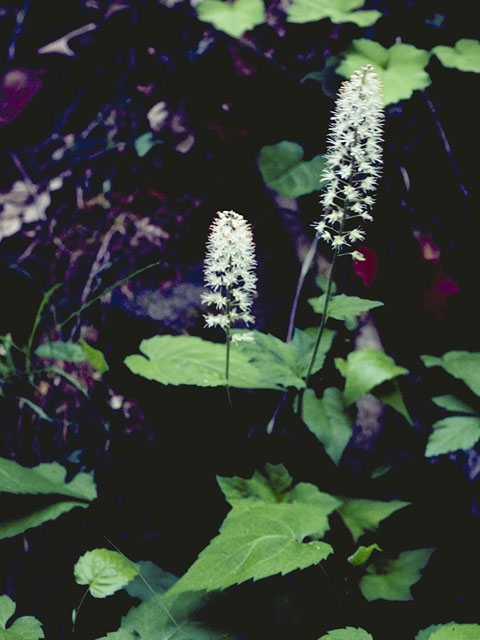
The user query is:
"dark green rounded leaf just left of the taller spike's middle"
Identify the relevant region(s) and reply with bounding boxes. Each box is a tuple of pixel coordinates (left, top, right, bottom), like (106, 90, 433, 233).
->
(258, 140, 325, 198)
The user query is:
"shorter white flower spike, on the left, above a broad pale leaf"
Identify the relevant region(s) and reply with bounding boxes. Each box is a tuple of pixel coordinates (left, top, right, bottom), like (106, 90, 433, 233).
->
(202, 211, 257, 332)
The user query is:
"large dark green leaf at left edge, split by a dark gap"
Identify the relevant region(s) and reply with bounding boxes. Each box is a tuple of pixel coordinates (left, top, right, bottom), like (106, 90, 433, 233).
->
(0, 458, 97, 539)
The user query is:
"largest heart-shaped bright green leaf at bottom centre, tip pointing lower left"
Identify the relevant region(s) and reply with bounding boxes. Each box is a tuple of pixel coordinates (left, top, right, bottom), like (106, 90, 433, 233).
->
(169, 503, 333, 593)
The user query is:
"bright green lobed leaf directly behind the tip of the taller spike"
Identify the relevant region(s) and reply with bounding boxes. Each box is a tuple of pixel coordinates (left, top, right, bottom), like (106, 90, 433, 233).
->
(337, 38, 431, 105)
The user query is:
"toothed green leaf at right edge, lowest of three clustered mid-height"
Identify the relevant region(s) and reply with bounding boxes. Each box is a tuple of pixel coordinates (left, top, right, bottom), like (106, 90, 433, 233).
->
(425, 416, 480, 457)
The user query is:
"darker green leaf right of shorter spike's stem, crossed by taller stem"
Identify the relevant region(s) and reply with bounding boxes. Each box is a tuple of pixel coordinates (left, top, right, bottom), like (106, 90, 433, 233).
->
(237, 329, 335, 389)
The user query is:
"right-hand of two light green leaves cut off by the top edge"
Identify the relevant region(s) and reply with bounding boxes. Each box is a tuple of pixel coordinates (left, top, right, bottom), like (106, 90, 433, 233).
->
(287, 0, 382, 27)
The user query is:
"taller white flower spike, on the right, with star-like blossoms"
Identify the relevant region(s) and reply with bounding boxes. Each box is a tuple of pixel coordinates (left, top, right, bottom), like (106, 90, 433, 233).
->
(313, 64, 384, 260)
